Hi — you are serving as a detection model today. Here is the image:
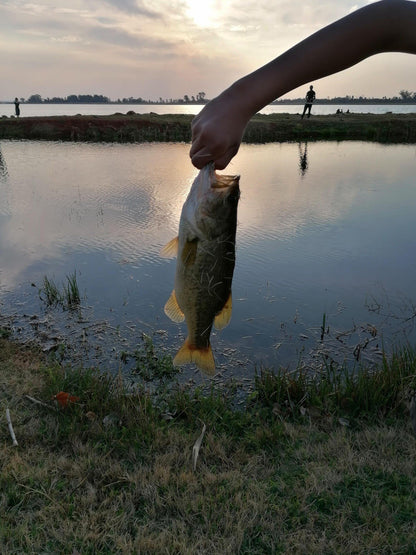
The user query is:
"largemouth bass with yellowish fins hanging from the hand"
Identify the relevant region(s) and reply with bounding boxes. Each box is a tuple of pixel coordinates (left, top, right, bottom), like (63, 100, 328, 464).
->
(161, 162, 240, 376)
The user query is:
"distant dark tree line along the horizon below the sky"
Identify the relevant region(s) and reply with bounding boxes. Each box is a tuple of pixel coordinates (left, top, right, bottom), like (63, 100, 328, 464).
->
(15, 90, 416, 104)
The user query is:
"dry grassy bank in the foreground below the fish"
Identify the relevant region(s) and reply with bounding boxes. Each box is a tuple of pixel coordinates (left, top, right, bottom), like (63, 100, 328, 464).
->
(0, 332, 416, 554)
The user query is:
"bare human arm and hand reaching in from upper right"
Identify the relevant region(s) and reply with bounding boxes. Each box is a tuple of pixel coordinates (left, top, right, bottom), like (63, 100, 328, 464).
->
(190, 0, 416, 169)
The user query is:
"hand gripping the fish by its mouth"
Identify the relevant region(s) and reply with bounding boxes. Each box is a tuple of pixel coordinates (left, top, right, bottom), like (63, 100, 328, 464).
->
(189, 91, 249, 170)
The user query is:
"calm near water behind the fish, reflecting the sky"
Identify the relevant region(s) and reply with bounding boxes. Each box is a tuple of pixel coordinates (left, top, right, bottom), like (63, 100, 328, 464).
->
(0, 141, 416, 384)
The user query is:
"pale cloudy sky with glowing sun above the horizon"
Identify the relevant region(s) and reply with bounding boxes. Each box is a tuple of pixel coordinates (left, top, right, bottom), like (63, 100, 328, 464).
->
(0, 0, 416, 101)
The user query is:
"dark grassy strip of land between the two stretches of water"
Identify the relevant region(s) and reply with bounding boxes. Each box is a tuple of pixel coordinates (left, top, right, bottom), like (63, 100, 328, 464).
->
(0, 110, 416, 143)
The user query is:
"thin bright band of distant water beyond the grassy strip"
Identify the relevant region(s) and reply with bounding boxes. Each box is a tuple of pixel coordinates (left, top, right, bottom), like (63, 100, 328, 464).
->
(0, 103, 416, 117)
